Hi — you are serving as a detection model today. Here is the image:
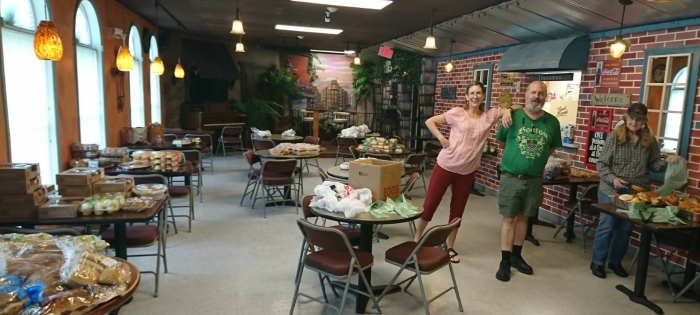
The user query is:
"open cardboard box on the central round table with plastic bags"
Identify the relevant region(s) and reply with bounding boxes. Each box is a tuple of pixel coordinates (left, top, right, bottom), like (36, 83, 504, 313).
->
(348, 159, 403, 201)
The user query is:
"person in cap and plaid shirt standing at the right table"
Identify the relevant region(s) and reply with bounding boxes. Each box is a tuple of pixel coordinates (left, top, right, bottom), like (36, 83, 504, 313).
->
(591, 103, 680, 278)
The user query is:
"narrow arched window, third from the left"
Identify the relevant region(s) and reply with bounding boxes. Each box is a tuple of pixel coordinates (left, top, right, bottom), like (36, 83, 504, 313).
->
(129, 25, 146, 127)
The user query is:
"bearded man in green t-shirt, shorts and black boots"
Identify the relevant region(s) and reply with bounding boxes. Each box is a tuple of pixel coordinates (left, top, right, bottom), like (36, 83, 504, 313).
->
(496, 81, 562, 281)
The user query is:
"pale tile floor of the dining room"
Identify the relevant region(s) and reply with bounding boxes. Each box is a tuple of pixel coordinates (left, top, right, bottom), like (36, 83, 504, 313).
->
(121, 154, 700, 315)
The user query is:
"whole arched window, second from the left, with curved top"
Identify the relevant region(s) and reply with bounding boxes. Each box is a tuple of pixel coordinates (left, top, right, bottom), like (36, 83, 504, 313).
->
(75, 0, 107, 148)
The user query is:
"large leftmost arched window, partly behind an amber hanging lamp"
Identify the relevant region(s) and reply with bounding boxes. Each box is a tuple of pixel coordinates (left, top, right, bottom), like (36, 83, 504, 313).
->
(0, 0, 59, 184)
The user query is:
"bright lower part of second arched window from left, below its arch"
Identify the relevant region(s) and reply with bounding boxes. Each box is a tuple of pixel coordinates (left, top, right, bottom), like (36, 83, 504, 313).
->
(76, 46, 107, 148)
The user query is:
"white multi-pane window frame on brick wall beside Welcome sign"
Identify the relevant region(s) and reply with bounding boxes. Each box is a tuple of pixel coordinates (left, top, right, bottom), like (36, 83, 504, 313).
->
(643, 53, 692, 154)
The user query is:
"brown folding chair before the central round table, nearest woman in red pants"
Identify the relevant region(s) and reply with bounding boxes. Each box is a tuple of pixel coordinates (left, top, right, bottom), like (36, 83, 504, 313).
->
(377, 218, 464, 315)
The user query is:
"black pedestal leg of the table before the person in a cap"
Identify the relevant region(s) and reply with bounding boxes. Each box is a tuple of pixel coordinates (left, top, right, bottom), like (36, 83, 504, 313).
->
(615, 227, 664, 314)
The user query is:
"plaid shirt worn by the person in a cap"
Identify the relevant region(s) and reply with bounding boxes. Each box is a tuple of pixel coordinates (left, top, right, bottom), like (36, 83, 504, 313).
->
(597, 132, 666, 196)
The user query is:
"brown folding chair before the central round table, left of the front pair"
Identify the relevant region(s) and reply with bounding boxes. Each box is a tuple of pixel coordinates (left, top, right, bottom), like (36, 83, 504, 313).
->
(289, 219, 381, 315)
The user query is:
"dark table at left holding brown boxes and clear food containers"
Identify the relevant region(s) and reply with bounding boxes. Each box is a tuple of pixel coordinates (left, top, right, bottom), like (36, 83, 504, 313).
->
(0, 199, 167, 259)
